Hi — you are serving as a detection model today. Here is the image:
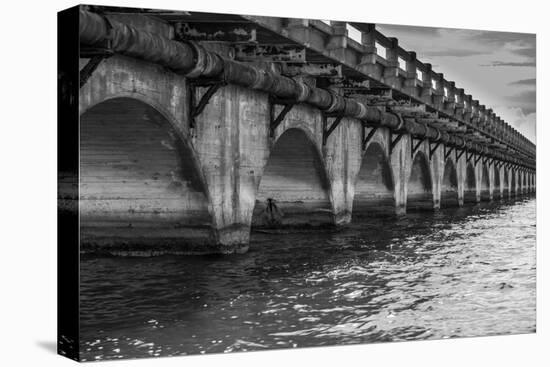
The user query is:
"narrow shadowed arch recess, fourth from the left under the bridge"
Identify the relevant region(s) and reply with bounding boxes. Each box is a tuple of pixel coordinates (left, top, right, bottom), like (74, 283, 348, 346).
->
(407, 152, 434, 211)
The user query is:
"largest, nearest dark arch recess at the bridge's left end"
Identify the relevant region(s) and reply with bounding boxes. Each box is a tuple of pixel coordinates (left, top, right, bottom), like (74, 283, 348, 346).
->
(80, 97, 212, 251)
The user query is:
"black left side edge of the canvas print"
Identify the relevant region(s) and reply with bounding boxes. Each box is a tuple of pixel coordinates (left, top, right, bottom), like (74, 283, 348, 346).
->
(57, 7, 79, 360)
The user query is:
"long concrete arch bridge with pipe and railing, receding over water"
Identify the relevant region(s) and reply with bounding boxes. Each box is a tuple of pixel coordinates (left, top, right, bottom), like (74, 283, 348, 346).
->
(59, 6, 536, 254)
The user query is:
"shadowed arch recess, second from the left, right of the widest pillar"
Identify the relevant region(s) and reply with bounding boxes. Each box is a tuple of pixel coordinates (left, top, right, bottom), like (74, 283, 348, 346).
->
(252, 128, 334, 228)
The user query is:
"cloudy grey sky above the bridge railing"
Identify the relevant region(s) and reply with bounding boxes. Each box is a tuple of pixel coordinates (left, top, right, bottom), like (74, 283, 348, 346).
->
(376, 24, 536, 143)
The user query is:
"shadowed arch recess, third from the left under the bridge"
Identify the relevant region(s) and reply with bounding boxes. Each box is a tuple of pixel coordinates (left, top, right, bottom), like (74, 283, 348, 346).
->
(352, 142, 395, 221)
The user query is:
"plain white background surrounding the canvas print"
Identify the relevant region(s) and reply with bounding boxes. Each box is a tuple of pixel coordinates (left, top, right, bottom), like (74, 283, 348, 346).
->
(0, 0, 550, 367)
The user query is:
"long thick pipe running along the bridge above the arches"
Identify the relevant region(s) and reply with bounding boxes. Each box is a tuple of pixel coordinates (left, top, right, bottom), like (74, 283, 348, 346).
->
(79, 9, 536, 170)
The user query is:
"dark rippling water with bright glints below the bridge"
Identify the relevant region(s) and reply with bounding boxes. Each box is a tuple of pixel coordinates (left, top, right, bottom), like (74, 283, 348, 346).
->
(81, 198, 536, 360)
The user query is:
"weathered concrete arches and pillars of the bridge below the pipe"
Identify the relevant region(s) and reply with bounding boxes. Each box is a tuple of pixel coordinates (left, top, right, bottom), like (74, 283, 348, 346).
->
(79, 42, 534, 254)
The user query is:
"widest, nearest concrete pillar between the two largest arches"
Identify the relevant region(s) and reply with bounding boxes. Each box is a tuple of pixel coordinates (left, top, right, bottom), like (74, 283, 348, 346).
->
(193, 86, 269, 253)
